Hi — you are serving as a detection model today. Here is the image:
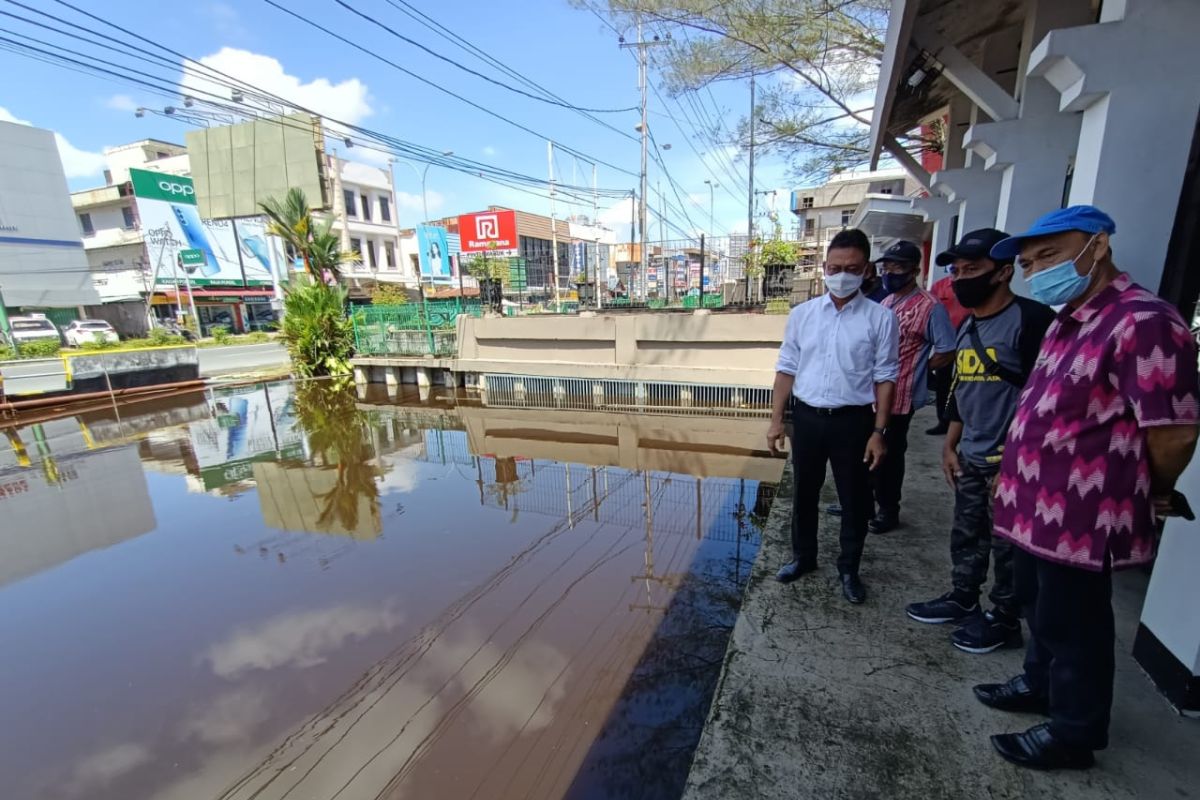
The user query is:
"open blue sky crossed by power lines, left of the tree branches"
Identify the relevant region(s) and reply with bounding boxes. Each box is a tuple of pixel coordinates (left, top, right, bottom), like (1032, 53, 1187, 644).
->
(0, 0, 806, 239)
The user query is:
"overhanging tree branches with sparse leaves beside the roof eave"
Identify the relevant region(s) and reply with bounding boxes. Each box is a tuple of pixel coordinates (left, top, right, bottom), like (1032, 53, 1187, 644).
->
(571, 0, 912, 176)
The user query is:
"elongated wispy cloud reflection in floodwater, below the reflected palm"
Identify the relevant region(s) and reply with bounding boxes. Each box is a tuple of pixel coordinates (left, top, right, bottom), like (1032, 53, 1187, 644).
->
(204, 602, 403, 678)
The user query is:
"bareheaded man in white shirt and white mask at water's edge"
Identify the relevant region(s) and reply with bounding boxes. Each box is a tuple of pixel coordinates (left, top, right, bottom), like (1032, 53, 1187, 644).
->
(767, 229, 900, 603)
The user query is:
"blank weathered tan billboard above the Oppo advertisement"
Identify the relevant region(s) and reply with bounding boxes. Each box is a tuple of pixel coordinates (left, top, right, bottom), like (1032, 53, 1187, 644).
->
(187, 114, 329, 219)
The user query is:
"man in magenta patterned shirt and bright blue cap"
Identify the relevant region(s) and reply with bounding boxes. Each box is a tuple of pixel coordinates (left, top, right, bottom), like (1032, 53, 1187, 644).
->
(974, 205, 1200, 769)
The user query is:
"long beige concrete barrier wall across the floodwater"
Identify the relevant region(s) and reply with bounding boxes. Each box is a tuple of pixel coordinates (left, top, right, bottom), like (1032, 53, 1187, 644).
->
(455, 313, 787, 386)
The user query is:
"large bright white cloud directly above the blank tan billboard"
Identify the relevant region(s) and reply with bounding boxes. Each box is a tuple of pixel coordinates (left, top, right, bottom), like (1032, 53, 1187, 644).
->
(180, 47, 373, 125)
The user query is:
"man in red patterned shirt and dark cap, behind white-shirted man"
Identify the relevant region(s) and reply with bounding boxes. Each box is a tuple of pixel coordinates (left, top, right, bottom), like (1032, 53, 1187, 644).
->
(870, 240, 955, 534)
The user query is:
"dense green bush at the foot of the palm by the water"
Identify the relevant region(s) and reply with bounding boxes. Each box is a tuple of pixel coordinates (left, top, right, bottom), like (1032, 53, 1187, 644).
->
(282, 281, 354, 378)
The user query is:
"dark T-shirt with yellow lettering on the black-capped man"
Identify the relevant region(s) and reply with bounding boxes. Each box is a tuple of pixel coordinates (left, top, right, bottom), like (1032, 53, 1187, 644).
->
(948, 297, 1055, 467)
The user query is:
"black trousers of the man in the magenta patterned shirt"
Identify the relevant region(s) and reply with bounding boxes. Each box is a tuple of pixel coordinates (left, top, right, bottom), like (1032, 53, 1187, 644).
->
(1014, 549, 1116, 750)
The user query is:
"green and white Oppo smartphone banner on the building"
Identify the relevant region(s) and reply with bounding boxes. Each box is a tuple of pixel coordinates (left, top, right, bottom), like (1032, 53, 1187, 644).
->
(130, 169, 278, 287)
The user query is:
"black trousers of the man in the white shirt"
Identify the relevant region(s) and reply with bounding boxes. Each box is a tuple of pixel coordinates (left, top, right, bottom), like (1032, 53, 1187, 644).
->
(792, 403, 875, 575)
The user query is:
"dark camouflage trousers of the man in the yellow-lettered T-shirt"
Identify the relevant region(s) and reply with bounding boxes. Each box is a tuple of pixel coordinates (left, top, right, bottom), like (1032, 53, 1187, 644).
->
(950, 458, 1021, 616)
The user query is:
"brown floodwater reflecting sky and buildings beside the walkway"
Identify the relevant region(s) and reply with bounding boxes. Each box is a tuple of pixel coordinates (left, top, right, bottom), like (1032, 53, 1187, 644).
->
(0, 383, 782, 800)
